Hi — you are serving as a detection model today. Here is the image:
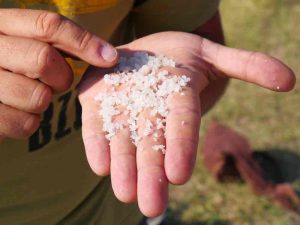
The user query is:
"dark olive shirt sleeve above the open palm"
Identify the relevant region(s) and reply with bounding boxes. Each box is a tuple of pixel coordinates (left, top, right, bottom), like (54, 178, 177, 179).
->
(132, 0, 220, 35)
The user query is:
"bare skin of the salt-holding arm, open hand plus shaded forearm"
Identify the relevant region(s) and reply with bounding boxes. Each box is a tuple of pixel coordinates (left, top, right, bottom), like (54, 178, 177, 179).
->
(80, 12, 295, 216)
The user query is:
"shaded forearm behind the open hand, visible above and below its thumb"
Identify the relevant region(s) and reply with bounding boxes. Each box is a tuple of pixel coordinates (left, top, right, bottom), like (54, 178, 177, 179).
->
(192, 12, 229, 115)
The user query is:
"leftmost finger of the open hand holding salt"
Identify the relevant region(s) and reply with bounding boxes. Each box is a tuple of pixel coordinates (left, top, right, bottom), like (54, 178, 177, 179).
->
(79, 68, 110, 176)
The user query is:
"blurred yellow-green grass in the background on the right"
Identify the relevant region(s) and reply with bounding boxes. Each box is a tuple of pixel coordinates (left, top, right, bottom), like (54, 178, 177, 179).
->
(168, 0, 300, 225)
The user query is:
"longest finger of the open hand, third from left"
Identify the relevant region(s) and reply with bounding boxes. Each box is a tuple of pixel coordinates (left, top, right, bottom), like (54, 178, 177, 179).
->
(136, 114, 168, 217)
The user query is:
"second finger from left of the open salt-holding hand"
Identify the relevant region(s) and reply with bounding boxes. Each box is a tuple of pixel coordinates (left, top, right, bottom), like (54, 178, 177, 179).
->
(110, 116, 137, 203)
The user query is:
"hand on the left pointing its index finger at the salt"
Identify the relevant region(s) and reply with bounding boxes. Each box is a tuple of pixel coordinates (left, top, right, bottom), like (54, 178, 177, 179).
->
(0, 9, 117, 138)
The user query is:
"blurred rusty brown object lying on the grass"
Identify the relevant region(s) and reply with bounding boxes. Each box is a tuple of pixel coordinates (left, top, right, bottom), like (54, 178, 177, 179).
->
(203, 121, 300, 214)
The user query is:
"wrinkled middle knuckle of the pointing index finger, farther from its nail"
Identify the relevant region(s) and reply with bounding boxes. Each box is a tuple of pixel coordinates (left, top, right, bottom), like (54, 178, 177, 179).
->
(35, 11, 64, 39)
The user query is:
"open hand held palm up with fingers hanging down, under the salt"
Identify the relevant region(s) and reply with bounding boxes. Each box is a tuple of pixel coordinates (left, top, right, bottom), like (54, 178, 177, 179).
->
(79, 32, 295, 217)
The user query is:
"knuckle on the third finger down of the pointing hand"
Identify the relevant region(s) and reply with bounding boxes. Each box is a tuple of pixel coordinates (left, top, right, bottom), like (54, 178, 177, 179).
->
(31, 82, 52, 113)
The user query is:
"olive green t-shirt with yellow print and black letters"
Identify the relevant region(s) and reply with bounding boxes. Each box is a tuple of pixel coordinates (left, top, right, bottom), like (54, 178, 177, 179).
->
(0, 0, 219, 225)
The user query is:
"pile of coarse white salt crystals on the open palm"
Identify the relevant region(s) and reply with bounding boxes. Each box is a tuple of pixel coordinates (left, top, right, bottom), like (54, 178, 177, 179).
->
(95, 52, 190, 153)
